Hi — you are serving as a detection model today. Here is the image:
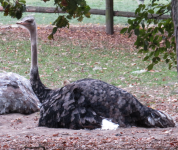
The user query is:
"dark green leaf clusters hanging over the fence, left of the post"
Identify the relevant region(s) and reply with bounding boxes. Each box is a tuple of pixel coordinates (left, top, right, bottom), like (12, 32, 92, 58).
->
(0, 0, 90, 39)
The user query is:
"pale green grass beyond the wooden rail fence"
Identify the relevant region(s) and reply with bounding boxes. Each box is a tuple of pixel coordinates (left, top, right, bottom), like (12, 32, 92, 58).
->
(0, 0, 170, 25)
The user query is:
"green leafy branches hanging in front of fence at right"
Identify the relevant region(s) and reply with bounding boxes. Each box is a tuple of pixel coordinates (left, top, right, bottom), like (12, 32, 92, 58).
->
(121, 0, 174, 70)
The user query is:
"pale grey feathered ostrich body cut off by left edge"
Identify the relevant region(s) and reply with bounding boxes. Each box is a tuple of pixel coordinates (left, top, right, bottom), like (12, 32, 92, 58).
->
(0, 72, 39, 115)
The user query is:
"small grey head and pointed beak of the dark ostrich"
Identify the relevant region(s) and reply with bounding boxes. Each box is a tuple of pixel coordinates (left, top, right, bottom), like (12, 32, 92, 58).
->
(16, 16, 36, 32)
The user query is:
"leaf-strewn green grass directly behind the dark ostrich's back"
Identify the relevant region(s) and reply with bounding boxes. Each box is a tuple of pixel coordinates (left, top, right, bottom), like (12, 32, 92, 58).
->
(0, 30, 177, 87)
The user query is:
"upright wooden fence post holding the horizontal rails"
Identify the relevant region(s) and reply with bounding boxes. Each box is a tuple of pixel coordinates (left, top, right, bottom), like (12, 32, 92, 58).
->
(105, 0, 114, 35)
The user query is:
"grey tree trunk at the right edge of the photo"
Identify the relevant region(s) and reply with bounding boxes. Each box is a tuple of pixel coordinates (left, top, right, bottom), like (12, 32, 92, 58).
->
(172, 0, 178, 76)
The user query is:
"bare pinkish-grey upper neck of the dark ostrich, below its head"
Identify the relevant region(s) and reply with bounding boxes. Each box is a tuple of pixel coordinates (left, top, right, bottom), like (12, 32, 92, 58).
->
(30, 26, 38, 69)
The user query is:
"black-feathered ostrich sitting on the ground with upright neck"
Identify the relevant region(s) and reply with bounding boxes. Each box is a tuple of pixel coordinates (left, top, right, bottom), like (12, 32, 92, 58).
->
(17, 16, 175, 129)
